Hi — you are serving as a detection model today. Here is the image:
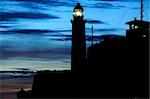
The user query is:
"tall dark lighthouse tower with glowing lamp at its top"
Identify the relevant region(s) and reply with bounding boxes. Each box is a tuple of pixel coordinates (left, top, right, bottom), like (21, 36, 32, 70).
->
(71, 3, 86, 73)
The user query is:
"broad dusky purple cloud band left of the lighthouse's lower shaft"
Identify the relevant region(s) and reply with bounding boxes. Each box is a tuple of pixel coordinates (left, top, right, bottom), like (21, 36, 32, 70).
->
(0, 48, 70, 61)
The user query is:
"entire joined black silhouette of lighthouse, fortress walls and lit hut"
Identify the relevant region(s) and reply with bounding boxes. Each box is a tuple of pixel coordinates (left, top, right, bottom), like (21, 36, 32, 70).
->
(17, 3, 149, 98)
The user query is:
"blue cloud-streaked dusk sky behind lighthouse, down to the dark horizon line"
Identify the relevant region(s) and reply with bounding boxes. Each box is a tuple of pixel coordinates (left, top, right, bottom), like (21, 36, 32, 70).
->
(0, 0, 150, 71)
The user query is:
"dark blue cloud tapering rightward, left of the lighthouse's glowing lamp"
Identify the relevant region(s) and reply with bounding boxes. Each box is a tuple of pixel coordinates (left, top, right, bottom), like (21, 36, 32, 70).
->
(0, 12, 60, 21)
